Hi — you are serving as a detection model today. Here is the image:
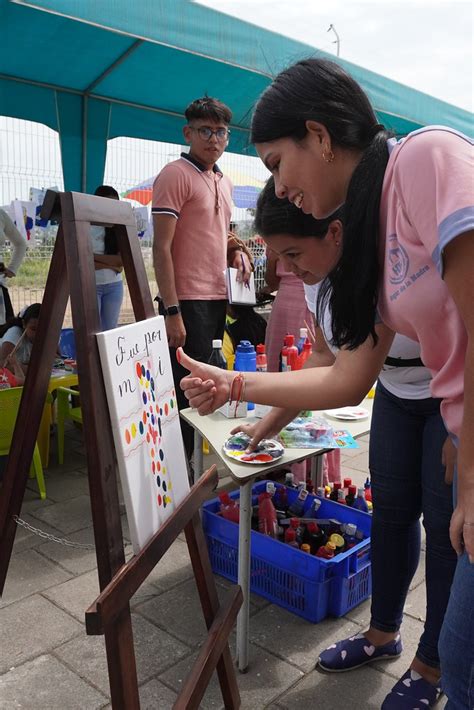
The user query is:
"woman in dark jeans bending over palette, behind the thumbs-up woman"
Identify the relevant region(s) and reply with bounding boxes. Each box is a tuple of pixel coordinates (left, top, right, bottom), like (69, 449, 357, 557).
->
(254, 178, 456, 710)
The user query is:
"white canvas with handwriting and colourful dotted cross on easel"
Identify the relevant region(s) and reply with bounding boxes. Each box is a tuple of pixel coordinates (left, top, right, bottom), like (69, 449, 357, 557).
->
(97, 316, 189, 553)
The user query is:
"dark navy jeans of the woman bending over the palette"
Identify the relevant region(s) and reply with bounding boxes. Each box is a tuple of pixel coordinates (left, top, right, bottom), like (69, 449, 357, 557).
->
(369, 382, 457, 668)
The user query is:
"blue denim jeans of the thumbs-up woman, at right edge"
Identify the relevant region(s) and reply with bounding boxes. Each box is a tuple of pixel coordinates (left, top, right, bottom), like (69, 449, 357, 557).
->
(439, 516, 474, 710)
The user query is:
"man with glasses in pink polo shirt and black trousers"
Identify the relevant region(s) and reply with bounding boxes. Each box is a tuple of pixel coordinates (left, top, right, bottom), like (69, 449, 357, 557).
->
(152, 96, 250, 457)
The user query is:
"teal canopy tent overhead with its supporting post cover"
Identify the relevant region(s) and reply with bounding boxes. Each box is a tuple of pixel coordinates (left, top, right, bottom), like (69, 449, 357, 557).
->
(0, 0, 472, 192)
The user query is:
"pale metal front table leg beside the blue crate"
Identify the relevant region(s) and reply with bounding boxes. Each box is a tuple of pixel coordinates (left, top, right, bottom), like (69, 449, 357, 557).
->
(237, 482, 252, 673)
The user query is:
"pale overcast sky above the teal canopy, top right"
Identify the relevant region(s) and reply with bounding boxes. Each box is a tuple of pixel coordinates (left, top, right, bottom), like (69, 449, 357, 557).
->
(199, 0, 474, 111)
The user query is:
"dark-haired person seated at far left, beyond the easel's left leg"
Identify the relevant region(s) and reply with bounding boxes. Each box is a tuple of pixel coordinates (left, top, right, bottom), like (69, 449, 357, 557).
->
(0, 303, 41, 372)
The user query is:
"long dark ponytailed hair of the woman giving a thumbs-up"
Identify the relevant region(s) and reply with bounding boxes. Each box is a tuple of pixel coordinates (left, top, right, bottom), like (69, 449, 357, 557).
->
(251, 59, 393, 349)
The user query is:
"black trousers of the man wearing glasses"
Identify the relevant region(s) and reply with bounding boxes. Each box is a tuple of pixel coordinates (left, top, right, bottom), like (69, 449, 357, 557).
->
(160, 301, 227, 459)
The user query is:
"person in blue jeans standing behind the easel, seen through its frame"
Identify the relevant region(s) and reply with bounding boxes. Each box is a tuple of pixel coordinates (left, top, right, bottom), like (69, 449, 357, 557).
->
(90, 185, 123, 330)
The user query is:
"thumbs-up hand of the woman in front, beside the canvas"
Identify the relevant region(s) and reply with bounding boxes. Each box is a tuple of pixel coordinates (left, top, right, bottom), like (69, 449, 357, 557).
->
(176, 348, 234, 414)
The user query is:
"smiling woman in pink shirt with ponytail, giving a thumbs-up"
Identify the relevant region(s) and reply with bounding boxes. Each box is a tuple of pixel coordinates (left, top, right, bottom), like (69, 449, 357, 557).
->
(182, 59, 474, 710)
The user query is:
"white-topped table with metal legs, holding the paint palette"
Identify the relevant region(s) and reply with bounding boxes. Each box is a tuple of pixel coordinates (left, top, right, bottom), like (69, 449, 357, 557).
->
(181, 398, 373, 673)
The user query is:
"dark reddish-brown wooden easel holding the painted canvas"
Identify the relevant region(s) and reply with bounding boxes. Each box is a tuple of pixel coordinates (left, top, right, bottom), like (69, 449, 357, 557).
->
(0, 191, 242, 710)
